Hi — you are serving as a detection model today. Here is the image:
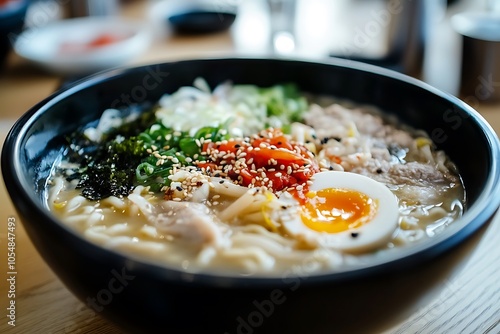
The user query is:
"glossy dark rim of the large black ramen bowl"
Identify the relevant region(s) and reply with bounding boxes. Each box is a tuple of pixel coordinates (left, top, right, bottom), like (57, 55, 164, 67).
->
(1, 56, 500, 287)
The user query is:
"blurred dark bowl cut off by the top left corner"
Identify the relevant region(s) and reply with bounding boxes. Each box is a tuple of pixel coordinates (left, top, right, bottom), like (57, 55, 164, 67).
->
(0, 0, 29, 66)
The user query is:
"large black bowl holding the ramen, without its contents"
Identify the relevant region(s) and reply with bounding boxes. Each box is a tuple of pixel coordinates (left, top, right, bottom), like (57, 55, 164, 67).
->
(2, 59, 500, 333)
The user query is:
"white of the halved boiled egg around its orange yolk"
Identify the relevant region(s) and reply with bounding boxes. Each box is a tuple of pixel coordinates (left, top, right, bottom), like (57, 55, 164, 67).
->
(280, 171, 399, 253)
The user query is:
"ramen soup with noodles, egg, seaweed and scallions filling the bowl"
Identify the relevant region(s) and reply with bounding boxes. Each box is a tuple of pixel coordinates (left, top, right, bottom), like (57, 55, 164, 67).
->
(47, 79, 465, 276)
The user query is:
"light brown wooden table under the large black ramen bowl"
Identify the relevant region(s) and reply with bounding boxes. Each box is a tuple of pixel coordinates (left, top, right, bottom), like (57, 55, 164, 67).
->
(0, 2, 500, 333)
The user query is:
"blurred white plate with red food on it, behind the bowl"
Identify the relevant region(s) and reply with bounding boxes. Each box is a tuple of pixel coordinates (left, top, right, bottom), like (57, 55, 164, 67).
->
(14, 17, 151, 74)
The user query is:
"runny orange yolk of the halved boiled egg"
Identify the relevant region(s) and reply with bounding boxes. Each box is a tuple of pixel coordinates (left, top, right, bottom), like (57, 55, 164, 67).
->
(302, 188, 378, 233)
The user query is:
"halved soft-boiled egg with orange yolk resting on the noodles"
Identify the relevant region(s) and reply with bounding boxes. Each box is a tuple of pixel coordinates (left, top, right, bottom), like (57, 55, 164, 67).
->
(279, 171, 399, 252)
